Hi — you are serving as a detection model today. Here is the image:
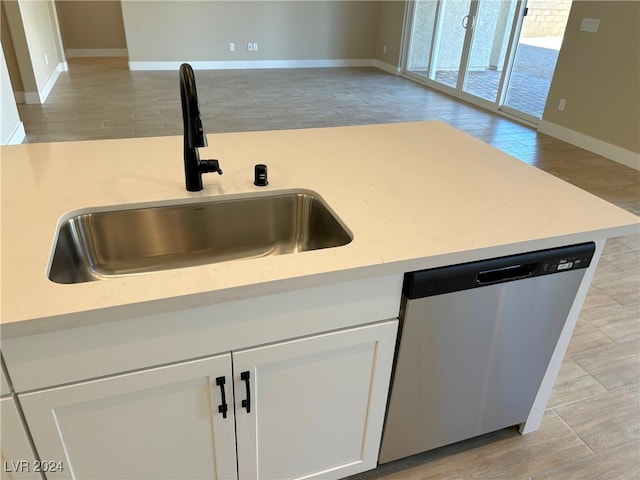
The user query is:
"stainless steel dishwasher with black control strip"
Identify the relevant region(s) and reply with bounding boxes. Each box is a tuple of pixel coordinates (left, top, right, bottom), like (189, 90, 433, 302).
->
(379, 243, 595, 463)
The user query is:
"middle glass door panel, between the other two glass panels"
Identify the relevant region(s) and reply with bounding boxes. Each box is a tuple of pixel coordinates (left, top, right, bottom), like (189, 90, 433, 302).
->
(429, 0, 472, 89)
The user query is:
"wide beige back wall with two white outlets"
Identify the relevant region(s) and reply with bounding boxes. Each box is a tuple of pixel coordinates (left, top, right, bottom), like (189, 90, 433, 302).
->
(122, 0, 380, 62)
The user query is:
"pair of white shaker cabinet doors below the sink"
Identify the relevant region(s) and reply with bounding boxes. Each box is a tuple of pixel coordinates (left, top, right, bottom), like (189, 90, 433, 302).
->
(19, 320, 397, 480)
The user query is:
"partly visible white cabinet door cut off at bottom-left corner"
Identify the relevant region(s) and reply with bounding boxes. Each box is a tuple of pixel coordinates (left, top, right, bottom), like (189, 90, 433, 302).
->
(0, 397, 41, 480)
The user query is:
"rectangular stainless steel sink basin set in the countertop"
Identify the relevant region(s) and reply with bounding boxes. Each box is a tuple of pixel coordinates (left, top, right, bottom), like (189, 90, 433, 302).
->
(49, 191, 352, 283)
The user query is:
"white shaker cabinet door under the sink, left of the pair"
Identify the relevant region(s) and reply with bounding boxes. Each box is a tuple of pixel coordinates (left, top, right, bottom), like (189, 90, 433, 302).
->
(19, 354, 237, 480)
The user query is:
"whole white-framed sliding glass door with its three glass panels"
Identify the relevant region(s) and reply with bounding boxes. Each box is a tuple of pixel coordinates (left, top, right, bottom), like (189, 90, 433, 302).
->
(404, 0, 524, 110)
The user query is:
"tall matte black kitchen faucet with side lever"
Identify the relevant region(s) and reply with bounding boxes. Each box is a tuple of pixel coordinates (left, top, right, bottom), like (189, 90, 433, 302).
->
(180, 63, 222, 192)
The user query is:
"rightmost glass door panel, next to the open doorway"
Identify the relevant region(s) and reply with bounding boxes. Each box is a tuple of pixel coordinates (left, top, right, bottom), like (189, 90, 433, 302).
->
(462, 0, 518, 103)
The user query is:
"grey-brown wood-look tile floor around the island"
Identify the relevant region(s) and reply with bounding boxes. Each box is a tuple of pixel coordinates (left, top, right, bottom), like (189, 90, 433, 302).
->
(19, 59, 640, 480)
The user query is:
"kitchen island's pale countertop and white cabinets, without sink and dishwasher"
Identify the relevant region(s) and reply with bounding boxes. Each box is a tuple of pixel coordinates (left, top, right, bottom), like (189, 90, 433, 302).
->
(2, 122, 638, 478)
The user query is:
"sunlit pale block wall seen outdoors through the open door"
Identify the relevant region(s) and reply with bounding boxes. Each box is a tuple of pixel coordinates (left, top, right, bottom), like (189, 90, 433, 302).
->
(521, 0, 572, 38)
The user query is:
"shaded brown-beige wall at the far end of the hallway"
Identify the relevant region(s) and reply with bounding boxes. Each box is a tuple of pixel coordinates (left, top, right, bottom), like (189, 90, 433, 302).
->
(56, 0, 127, 49)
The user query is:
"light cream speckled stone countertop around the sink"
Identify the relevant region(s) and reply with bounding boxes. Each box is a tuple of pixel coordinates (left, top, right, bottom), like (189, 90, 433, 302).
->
(0, 122, 639, 338)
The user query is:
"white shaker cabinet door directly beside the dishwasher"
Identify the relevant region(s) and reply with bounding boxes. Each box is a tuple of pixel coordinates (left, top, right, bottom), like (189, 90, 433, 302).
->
(232, 321, 397, 480)
